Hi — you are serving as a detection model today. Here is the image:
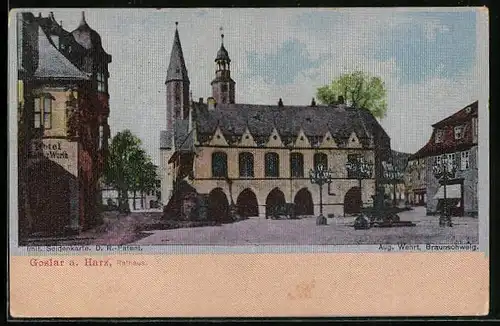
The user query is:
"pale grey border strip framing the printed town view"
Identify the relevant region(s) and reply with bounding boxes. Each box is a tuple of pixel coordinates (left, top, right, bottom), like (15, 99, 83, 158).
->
(7, 7, 490, 256)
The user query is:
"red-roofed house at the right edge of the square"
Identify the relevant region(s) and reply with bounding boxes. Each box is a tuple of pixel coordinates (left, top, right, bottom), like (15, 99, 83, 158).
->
(412, 101, 478, 216)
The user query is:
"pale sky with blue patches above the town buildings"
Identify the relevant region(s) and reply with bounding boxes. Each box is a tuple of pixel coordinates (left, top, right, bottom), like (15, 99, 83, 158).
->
(18, 8, 487, 163)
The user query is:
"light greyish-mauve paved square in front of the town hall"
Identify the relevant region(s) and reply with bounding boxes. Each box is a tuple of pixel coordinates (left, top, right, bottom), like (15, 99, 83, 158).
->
(134, 207, 478, 246)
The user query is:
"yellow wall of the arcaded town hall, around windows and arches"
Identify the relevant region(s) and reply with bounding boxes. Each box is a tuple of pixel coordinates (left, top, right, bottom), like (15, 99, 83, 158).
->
(192, 147, 375, 216)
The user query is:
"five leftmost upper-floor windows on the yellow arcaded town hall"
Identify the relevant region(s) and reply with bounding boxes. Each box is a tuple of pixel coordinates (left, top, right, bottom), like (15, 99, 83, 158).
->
(212, 152, 344, 178)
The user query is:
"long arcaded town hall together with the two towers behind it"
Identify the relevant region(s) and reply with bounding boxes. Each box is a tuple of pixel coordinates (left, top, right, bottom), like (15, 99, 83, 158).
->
(160, 24, 390, 219)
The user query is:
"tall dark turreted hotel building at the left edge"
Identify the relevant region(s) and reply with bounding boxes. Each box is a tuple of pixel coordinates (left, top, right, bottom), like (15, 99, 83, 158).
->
(17, 13, 111, 238)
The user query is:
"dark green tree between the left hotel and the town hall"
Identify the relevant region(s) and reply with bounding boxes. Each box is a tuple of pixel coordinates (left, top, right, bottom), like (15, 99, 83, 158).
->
(104, 130, 157, 212)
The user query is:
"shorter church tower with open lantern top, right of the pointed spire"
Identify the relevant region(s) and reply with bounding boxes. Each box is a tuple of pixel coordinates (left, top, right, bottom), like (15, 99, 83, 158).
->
(211, 34, 236, 104)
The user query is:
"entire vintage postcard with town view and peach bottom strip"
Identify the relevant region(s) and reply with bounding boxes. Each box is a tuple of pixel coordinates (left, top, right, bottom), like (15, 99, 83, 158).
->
(8, 7, 489, 317)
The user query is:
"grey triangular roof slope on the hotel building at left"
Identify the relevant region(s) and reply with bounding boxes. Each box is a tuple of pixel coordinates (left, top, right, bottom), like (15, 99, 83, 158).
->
(33, 25, 89, 80)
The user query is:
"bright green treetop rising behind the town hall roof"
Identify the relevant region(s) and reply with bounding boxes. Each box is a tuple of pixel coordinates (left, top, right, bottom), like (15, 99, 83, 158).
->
(316, 71, 387, 118)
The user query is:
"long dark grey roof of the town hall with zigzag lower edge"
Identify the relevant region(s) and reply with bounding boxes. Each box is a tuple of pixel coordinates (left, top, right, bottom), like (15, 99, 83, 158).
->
(193, 103, 388, 145)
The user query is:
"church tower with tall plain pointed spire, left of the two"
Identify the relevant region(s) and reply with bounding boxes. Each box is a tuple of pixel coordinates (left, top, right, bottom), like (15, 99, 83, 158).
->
(165, 22, 189, 132)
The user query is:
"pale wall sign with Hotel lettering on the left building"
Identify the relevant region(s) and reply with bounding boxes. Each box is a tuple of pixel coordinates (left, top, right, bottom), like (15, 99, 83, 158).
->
(31, 139, 78, 176)
